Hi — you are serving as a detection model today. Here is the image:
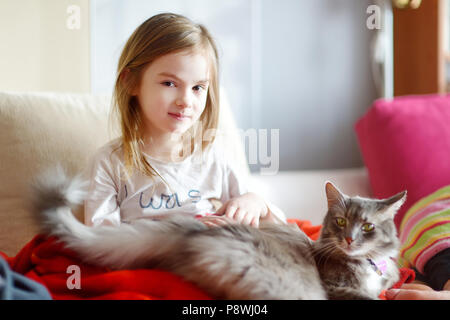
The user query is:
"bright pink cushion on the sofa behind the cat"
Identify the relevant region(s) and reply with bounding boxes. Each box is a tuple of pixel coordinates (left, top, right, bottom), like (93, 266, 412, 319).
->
(355, 95, 450, 226)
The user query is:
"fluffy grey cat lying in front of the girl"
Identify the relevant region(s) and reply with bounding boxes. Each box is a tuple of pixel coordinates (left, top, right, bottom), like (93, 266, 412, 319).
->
(32, 172, 406, 299)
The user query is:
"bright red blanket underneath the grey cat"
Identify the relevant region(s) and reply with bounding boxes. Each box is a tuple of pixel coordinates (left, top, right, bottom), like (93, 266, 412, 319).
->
(0, 219, 414, 300)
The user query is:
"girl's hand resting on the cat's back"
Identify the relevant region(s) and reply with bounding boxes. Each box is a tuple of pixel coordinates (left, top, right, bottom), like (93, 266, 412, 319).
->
(216, 192, 269, 228)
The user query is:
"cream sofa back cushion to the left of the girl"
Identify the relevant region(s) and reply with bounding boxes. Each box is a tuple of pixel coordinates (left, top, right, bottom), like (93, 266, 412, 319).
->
(0, 93, 113, 254)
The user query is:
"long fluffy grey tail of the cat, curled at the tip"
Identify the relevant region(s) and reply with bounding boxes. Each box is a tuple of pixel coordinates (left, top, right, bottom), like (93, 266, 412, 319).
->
(32, 168, 203, 269)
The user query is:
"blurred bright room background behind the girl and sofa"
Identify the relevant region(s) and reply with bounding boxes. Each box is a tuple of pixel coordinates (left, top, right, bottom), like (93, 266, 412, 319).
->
(0, 0, 450, 171)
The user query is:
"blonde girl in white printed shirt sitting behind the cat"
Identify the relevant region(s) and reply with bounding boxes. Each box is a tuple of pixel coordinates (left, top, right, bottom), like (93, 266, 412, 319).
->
(85, 13, 285, 227)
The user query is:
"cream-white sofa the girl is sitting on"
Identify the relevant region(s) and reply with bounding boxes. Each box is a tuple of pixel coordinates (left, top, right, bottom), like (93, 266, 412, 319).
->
(0, 92, 370, 255)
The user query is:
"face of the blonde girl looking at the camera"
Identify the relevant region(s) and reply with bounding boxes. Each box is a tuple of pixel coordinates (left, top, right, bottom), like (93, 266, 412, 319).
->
(134, 51, 209, 137)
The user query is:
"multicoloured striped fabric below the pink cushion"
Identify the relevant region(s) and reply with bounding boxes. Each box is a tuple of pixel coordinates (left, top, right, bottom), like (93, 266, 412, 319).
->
(398, 186, 450, 273)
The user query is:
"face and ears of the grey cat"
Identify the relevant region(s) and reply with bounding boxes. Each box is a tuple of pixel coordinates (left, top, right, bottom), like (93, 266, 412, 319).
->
(321, 183, 406, 259)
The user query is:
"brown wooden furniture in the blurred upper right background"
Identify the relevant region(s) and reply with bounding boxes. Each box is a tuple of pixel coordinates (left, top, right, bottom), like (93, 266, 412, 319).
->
(393, 0, 450, 96)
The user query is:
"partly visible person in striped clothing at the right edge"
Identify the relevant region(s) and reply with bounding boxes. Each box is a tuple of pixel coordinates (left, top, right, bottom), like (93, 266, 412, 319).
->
(386, 186, 450, 300)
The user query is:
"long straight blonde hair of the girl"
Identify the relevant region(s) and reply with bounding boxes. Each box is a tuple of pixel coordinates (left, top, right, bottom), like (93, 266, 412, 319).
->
(113, 13, 219, 180)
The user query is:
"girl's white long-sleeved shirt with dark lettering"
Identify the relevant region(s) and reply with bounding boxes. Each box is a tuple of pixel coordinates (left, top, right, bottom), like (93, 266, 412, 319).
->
(85, 138, 284, 226)
